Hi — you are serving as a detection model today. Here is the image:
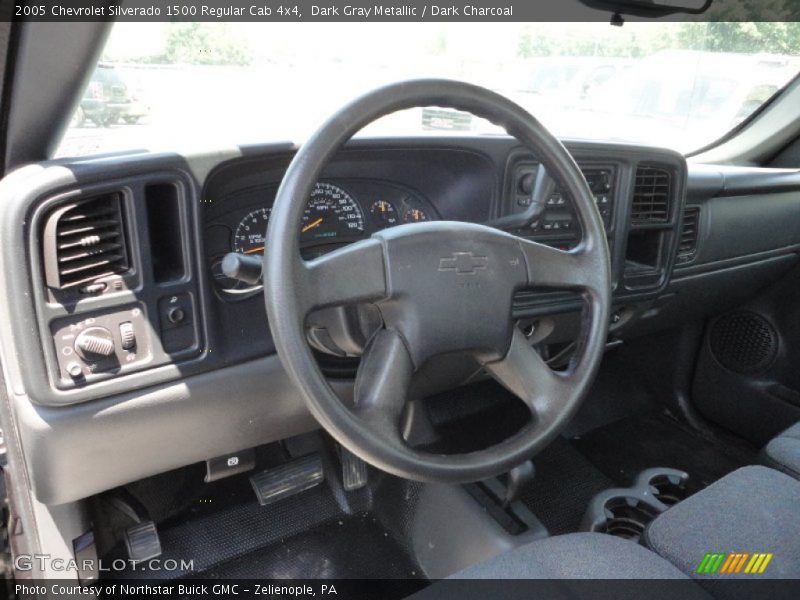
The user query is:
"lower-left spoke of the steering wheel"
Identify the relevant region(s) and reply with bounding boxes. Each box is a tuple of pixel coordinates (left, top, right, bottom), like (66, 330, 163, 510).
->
(353, 329, 414, 443)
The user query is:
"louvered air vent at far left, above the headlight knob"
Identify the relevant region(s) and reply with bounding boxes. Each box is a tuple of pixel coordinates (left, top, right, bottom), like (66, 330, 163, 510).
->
(43, 193, 129, 289)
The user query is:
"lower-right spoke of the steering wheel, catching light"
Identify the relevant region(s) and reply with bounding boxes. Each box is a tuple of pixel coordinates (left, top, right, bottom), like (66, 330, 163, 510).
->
(486, 327, 571, 421)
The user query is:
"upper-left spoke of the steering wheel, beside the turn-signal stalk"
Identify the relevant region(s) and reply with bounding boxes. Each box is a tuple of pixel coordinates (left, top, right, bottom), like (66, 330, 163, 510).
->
(298, 239, 386, 314)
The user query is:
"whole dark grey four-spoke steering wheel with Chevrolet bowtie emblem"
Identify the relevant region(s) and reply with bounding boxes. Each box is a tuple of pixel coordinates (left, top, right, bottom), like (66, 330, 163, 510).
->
(263, 80, 611, 483)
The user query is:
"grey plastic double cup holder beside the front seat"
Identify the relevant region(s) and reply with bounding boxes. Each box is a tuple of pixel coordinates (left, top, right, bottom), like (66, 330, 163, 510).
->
(581, 468, 689, 542)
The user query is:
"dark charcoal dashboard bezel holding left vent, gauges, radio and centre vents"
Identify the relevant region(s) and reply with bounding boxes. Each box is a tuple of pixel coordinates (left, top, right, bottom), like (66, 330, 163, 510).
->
(18, 139, 686, 404)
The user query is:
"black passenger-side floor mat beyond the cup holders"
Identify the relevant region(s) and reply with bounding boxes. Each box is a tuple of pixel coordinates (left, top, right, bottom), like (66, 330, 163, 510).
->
(570, 412, 755, 491)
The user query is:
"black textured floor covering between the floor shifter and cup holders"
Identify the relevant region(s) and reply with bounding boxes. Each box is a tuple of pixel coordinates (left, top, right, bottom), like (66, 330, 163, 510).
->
(521, 437, 614, 535)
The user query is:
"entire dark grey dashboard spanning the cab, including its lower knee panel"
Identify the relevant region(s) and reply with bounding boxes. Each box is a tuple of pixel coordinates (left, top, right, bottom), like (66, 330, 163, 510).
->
(0, 136, 800, 504)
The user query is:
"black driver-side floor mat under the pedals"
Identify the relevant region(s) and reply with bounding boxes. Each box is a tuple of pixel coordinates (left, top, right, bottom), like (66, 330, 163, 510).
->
(104, 462, 423, 593)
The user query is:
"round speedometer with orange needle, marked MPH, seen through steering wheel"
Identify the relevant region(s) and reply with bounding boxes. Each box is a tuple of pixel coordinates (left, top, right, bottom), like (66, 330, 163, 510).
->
(300, 183, 364, 243)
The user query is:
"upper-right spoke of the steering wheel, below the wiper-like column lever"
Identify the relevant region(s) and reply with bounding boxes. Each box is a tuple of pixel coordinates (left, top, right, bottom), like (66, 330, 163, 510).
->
(520, 239, 605, 292)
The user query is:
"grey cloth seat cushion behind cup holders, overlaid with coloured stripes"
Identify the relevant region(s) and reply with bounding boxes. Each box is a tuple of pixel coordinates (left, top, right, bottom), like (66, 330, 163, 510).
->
(644, 466, 800, 587)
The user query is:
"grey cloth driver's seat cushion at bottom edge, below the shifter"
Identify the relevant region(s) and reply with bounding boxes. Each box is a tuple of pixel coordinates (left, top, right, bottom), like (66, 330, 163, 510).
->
(453, 533, 686, 579)
